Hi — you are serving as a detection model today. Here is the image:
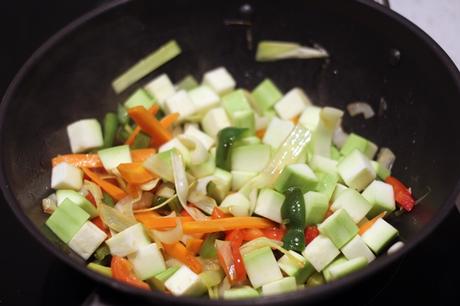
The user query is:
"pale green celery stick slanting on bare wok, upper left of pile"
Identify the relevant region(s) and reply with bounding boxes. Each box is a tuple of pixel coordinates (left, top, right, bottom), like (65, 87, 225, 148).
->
(112, 40, 181, 93)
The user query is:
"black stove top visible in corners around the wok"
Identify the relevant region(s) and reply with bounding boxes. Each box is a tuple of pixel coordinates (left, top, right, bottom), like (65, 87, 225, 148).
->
(0, 0, 460, 306)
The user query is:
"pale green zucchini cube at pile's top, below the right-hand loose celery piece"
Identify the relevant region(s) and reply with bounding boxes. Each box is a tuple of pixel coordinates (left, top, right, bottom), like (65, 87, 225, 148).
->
(251, 79, 283, 114)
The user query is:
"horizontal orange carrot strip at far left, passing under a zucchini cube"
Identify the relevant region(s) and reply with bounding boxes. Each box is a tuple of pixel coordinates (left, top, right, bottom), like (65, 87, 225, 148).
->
(51, 148, 156, 168)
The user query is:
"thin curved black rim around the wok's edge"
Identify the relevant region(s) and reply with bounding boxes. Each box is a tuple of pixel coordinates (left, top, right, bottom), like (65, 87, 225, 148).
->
(0, 0, 460, 305)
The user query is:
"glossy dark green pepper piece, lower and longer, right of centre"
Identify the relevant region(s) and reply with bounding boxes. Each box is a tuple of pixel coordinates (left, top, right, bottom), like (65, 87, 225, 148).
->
(281, 187, 305, 252)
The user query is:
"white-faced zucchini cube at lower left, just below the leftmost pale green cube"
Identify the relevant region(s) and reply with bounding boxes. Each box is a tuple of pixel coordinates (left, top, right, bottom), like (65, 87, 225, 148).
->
(69, 221, 107, 260)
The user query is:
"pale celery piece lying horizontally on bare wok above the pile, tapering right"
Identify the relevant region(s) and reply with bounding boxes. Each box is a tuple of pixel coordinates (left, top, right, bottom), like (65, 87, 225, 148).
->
(256, 40, 329, 62)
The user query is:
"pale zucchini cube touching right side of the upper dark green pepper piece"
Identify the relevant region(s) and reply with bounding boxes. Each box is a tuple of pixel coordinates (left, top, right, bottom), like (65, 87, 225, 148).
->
(231, 144, 271, 172)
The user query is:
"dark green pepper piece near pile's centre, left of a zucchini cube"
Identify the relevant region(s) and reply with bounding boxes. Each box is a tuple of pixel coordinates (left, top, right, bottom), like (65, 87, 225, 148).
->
(216, 127, 247, 171)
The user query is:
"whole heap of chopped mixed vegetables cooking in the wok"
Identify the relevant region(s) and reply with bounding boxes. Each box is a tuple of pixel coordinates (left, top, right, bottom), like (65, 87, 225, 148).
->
(43, 38, 415, 299)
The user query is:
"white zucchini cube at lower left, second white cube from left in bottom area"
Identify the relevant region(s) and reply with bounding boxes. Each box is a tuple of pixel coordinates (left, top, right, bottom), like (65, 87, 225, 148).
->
(105, 223, 150, 257)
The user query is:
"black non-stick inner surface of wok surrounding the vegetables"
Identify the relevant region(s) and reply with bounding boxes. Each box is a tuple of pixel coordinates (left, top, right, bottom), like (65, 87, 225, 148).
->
(0, 0, 460, 305)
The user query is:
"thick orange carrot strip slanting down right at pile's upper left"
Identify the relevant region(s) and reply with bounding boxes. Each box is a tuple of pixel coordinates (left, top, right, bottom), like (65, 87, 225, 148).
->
(128, 106, 172, 147)
